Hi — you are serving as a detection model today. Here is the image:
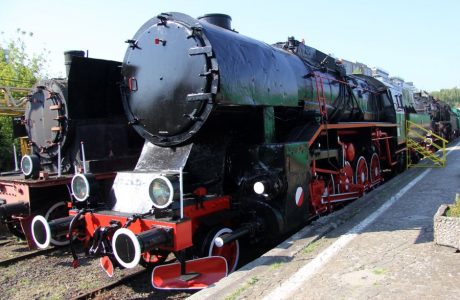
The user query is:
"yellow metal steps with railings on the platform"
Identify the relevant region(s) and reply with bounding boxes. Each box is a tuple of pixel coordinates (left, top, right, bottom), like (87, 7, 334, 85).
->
(406, 120, 448, 168)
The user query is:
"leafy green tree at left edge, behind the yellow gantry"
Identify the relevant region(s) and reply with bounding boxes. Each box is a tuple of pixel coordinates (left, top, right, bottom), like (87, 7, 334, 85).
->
(0, 29, 47, 171)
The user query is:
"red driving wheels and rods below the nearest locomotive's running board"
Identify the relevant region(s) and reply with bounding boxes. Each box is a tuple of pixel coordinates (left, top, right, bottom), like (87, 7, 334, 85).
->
(309, 123, 398, 214)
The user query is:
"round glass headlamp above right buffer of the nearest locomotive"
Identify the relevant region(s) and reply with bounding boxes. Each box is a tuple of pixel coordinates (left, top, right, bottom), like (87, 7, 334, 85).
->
(149, 176, 178, 208)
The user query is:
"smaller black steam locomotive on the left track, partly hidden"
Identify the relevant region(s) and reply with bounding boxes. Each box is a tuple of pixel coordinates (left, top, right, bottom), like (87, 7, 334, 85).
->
(0, 51, 143, 248)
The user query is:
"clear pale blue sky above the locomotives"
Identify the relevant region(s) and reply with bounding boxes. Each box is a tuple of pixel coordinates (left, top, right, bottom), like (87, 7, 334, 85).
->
(0, 0, 460, 91)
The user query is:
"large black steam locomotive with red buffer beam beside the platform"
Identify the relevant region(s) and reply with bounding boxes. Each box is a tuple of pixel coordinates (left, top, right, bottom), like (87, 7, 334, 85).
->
(31, 12, 456, 289)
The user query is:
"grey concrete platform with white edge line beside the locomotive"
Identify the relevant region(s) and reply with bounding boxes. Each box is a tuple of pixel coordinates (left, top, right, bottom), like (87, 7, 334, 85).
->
(190, 143, 460, 300)
